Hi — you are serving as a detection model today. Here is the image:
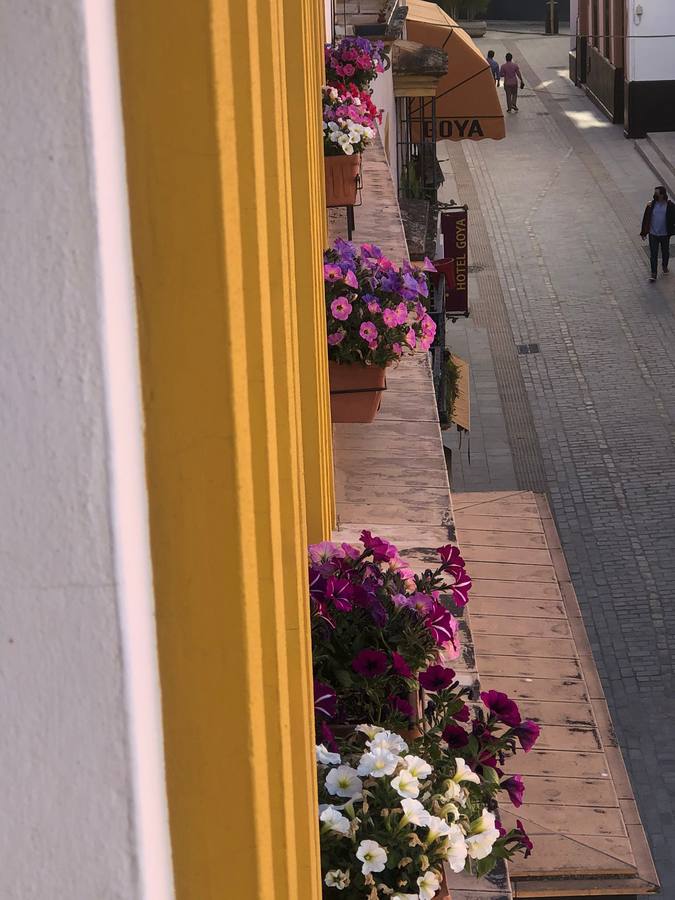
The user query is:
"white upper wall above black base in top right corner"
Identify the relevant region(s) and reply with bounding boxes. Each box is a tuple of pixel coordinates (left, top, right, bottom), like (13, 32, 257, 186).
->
(627, 0, 675, 81)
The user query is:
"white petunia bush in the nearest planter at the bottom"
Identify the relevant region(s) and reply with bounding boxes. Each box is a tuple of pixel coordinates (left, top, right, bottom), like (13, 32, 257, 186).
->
(317, 725, 529, 900)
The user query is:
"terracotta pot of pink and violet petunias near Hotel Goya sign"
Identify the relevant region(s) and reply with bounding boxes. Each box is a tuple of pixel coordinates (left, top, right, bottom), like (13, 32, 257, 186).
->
(324, 238, 436, 422)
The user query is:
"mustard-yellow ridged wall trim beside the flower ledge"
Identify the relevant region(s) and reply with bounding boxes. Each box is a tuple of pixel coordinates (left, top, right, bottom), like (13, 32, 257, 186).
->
(117, 0, 333, 900)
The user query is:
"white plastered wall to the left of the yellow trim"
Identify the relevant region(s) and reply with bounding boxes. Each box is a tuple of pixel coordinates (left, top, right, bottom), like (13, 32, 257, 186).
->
(0, 0, 170, 900)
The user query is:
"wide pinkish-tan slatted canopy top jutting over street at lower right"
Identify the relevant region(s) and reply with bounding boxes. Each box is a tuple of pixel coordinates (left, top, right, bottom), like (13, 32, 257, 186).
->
(453, 491, 657, 897)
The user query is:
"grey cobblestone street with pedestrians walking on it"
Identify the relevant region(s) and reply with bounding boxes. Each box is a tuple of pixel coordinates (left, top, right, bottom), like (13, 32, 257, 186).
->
(444, 34, 675, 898)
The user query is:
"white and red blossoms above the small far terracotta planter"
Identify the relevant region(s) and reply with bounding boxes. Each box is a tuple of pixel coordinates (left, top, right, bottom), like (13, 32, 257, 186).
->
(323, 85, 381, 156)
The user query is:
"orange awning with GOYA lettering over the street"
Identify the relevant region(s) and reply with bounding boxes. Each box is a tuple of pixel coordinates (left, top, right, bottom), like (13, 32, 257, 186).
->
(406, 0, 506, 141)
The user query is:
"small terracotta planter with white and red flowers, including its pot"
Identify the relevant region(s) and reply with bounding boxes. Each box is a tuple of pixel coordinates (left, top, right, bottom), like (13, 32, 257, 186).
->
(323, 85, 380, 207)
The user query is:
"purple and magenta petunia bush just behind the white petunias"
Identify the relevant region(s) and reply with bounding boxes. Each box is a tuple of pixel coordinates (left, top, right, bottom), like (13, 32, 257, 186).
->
(309, 531, 471, 746)
